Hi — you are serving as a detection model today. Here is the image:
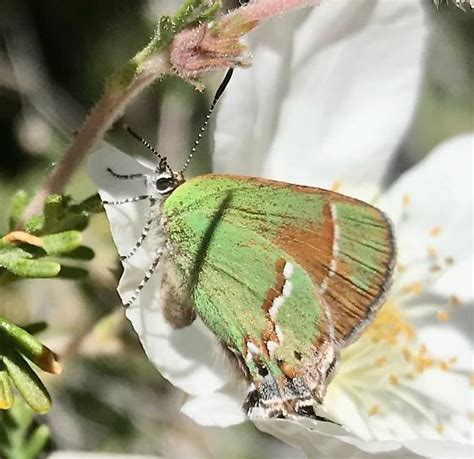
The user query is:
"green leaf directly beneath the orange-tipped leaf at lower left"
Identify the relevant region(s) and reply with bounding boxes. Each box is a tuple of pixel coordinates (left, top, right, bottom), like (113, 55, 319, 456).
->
(1, 349, 51, 413)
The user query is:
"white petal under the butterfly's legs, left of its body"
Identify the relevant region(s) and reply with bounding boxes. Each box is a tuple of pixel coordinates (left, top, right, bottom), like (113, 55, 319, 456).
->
(89, 146, 229, 395)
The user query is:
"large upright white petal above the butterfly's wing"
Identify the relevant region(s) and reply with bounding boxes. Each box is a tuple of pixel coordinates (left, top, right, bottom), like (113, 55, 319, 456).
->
(214, 0, 426, 187)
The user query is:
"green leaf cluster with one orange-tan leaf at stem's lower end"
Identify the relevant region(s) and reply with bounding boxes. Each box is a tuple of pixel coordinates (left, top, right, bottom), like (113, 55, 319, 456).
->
(0, 191, 102, 283)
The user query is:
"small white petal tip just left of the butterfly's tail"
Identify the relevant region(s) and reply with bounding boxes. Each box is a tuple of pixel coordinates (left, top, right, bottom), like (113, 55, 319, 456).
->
(181, 392, 247, 427)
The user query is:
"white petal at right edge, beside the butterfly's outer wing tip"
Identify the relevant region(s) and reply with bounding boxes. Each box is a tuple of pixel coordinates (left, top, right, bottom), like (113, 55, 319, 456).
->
(383, 135, 474, 301)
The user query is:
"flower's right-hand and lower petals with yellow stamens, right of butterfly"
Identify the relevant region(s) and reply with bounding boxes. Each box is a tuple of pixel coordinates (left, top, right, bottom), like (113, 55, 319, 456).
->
(252, 135, 474, 457)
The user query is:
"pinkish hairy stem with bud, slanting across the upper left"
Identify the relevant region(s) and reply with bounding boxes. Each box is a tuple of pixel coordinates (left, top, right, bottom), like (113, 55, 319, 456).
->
(23, 0, 320, 222)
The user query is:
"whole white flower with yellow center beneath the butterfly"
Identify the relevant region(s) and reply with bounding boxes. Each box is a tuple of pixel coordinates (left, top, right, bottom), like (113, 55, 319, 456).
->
(91, 0, 472, 458)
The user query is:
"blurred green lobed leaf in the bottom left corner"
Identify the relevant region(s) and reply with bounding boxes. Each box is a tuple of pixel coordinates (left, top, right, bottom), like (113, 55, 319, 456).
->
(0, 401, 50, 459)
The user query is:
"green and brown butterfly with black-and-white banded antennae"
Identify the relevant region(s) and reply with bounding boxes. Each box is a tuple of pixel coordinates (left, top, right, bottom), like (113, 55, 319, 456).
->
(92, 74, 396, 419)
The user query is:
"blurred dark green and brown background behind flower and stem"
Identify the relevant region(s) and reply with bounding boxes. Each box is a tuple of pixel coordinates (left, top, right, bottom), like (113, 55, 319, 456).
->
(0, 0, 474, 459)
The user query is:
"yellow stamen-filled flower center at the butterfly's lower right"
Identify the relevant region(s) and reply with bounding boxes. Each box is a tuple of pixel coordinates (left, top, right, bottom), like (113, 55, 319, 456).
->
(326, 297, 462, 438)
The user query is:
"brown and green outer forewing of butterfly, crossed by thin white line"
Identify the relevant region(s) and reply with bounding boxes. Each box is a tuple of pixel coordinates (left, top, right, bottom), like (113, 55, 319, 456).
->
(275, 193, 395, 345)
